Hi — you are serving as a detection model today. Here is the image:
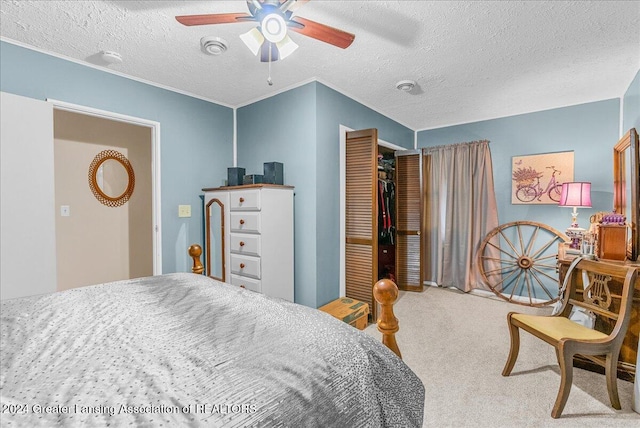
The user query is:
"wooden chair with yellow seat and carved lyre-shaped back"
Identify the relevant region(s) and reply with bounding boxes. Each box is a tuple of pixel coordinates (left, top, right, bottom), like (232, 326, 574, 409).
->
(502, 259, 638, 418)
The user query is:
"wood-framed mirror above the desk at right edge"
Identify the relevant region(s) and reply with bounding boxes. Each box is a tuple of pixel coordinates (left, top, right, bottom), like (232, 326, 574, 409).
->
(613, 128, 640, 261)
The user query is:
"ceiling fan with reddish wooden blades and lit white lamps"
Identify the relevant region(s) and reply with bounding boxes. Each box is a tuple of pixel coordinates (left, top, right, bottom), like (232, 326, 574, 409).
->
(176, 0, 356, 62)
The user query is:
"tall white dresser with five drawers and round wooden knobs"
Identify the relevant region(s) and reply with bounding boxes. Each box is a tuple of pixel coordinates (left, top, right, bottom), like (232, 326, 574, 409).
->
(202, 184, 293, 302)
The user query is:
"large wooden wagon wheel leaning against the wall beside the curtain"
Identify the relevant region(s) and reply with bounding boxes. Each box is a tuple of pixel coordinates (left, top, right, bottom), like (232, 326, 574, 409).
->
(477, 221, 568, 307)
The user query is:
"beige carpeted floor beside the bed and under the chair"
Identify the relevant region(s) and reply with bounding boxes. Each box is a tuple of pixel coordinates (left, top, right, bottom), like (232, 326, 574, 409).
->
(365, 287, 640, 428)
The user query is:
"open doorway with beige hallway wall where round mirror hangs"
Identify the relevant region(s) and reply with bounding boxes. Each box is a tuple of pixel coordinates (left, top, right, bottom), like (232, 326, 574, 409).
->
(54, 102, 162, 291)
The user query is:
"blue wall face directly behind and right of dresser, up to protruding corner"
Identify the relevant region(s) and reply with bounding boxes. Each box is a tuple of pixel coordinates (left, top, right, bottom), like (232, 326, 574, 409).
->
(237, 83, 316, 307)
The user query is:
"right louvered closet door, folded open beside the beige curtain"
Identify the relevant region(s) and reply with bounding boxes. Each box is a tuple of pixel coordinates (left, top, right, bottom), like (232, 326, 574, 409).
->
(396, 150, 423, 291)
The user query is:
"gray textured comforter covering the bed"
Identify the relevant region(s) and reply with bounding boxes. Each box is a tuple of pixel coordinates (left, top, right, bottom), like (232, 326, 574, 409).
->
(0, 274, 424, 427)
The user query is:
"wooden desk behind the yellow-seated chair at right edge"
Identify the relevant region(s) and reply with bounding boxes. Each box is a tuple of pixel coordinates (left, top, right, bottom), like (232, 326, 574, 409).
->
(558, 244, 640, 382)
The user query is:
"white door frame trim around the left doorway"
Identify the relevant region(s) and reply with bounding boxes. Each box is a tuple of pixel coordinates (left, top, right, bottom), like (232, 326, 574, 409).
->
(46, 98, 162, 275)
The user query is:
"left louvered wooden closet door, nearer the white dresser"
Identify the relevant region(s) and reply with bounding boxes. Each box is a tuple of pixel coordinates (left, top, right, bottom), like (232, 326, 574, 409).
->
(345, 129, 378, 320)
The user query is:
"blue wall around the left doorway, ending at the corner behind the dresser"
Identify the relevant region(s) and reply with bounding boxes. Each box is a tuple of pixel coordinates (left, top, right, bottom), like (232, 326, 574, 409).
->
(0, 42, 233, 272)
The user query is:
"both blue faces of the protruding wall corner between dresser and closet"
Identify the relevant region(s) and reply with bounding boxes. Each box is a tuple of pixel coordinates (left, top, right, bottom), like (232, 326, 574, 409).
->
(237, 82, 413, 307)
